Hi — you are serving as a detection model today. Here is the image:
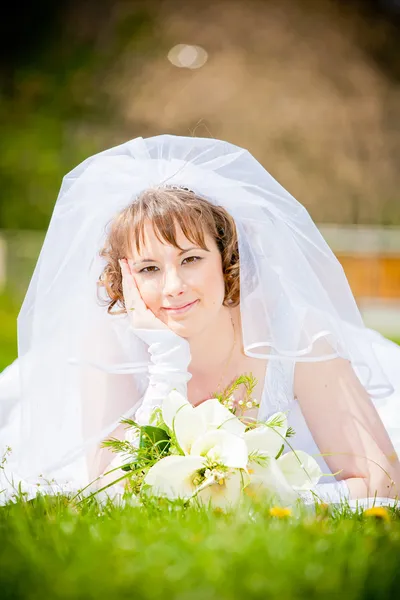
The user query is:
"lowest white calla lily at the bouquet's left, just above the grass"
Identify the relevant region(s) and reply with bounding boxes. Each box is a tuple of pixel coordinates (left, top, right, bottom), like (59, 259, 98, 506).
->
(144, 456, 205, 500)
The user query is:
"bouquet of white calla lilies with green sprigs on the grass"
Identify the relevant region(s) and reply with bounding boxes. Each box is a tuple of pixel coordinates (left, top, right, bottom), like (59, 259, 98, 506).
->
(98, 378, 322, 509)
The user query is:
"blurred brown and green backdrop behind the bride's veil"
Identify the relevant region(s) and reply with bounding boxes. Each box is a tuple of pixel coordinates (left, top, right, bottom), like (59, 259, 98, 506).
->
(0, 0, 400, 370)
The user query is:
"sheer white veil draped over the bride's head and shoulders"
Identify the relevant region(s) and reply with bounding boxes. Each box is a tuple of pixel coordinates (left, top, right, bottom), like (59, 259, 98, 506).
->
(0, 135, 400, 496)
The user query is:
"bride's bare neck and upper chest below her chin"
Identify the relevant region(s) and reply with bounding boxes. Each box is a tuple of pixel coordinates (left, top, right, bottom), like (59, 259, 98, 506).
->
(188, 307, 239, 374)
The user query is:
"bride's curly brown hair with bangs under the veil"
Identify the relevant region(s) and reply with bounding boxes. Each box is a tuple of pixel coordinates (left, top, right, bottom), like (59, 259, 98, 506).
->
(98, 187, 240, 314)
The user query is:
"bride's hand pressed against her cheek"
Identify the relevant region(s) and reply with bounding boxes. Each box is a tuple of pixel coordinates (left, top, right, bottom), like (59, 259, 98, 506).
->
(119, 258, 169, 329)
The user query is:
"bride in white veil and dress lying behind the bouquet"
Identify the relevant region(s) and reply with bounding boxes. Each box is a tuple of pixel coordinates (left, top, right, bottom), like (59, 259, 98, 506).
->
(0, 135, 400, 505)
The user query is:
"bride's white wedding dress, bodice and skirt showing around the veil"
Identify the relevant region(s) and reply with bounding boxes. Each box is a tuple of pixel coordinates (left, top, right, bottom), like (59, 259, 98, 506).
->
(0, 330, 400, 506)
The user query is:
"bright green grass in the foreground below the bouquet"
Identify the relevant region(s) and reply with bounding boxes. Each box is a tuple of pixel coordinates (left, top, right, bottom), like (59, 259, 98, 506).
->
(0, 497, 400, 600)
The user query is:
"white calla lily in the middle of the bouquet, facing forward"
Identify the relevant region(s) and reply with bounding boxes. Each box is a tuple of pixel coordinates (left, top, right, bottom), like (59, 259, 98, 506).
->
(191, 429, 248, 469)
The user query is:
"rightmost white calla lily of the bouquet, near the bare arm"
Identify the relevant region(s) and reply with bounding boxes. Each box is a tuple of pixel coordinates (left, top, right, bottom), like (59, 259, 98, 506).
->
(277, 450, 323, 491)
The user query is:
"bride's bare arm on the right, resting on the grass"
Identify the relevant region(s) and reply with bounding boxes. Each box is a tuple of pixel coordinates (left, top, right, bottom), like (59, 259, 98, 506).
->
(294, 358, 400, 499)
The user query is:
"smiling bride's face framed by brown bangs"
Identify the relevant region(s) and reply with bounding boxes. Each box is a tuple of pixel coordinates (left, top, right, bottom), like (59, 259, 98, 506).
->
(130, 222, 225, 338)
